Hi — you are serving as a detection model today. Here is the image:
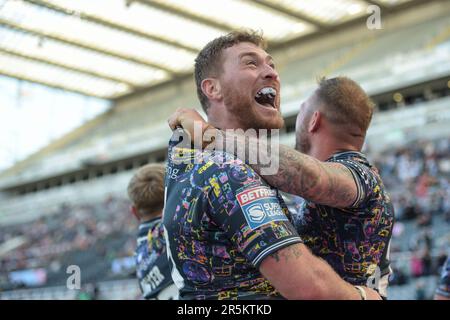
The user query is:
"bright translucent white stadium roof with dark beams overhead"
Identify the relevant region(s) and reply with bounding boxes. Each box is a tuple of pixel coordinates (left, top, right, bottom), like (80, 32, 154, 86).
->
(0, 0, 424, 99)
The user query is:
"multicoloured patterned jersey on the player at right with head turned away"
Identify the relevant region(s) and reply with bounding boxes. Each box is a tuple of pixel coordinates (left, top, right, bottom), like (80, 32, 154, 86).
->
(293, 151, 394, 297)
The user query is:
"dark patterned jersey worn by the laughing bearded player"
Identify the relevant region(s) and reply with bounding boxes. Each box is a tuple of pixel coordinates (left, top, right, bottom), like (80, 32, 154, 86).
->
(164, 131, 301, 299)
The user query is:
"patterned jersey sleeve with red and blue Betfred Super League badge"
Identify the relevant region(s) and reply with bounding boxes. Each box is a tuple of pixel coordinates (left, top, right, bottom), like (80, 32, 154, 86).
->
(205, 160, 302, 268)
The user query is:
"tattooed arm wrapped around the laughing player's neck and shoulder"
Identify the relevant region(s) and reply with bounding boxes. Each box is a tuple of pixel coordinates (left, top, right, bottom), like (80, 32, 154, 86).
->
(168, 108, 358, 208)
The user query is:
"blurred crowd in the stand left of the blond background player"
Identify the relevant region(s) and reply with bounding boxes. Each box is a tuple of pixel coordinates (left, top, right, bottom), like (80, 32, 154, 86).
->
(0, 196, 137, 290)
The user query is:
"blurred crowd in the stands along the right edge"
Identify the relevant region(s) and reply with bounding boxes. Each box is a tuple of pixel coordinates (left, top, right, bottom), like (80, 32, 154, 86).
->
(374, 138, 450, 299)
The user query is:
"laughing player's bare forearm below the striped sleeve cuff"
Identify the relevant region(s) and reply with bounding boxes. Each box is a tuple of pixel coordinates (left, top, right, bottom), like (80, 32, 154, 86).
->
(259, 243, 380, 300)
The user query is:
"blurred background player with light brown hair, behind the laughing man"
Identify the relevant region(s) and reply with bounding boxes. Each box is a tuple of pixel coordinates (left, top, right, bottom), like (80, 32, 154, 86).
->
(128, 163, 178, 300)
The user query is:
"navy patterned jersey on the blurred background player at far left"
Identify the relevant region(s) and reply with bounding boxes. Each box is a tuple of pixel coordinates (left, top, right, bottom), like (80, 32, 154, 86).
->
(134, 218, 173, 299)
